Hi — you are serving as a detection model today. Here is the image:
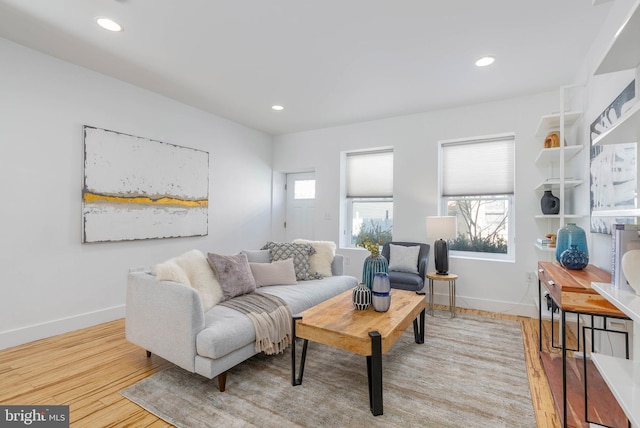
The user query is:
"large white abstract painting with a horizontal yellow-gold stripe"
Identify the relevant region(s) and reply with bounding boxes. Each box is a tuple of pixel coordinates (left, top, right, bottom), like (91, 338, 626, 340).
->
(82, 126, 209, 243)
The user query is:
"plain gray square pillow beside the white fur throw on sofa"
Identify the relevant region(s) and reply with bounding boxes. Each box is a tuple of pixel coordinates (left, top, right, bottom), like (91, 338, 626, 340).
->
(207, 253, 256, 300)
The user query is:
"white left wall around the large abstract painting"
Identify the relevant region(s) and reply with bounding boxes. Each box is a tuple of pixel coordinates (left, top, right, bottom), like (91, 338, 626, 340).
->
(0, 39, 272, 349)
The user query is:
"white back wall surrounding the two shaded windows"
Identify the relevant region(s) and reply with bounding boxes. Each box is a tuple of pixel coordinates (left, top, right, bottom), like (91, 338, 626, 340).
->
(273, 91, 559, 315)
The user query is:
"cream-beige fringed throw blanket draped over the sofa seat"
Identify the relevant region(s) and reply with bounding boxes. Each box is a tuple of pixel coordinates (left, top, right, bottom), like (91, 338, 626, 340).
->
(220, 293, 293, 355)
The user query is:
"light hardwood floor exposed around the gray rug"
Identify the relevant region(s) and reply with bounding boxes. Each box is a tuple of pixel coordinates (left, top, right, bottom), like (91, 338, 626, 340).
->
(0, 309, 560, 428)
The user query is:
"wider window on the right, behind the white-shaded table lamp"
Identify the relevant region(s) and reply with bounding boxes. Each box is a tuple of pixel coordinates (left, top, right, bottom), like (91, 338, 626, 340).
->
(440, 134, 515, 260)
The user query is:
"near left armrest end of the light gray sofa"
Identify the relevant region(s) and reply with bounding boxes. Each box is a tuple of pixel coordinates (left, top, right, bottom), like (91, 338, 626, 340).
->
(125, 272, 205, 372)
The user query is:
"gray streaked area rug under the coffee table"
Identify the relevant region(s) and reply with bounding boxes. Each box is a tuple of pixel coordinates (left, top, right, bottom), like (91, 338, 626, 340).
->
(121, 314, 536, 428)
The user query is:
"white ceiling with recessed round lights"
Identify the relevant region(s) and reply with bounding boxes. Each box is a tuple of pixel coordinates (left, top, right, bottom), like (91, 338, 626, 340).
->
(0, 0, 611, 135)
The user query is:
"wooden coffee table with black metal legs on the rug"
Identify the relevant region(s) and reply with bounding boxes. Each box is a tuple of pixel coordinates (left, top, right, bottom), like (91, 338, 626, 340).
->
(291, 289, 426, 416)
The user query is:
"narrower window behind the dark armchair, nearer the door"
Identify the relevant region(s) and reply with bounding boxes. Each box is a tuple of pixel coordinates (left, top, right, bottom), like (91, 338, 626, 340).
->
(346, 150, 393, 246)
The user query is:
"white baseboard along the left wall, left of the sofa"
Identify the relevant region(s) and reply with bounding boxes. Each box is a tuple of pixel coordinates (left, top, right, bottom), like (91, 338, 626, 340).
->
(0, 305, 125, 349)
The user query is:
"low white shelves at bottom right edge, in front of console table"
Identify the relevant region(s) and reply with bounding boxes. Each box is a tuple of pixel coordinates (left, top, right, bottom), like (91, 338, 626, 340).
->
(591, 282, 640, 427)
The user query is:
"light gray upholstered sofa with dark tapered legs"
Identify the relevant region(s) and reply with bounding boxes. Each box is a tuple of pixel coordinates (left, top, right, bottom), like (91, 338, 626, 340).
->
(126, 241, 358, 391)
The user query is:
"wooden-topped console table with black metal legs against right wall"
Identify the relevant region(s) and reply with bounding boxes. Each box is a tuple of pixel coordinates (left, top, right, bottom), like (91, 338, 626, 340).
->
(538, 262, 628, 427)
